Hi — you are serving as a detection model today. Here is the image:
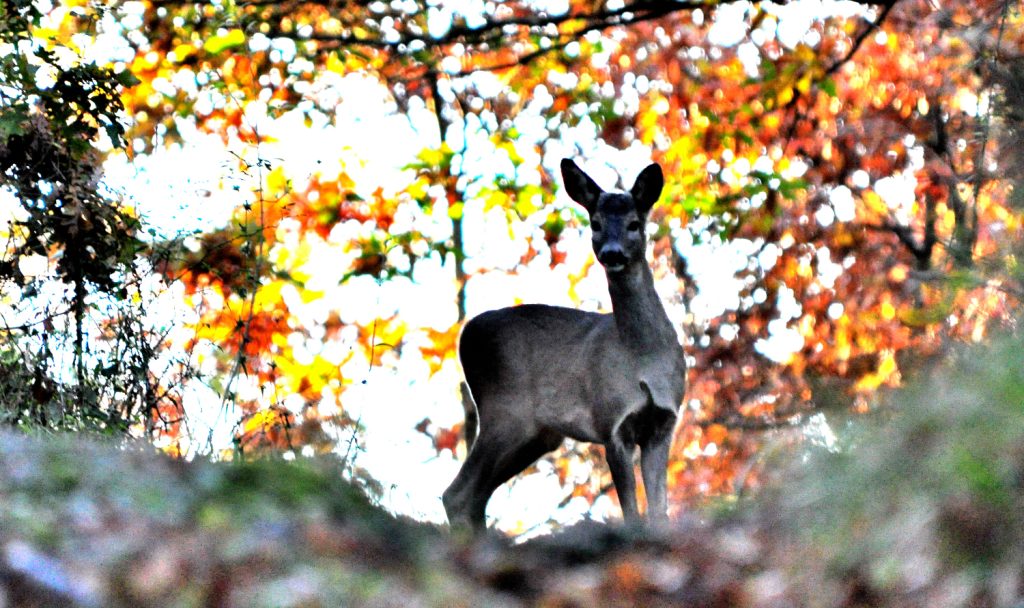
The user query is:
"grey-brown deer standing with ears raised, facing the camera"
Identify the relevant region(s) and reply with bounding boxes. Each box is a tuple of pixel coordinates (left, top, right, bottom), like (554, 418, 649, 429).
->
(441, 159, 686, 532)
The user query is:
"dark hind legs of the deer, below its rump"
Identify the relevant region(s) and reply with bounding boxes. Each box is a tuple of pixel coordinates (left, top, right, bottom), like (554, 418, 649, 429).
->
(441, 425, 561, 530)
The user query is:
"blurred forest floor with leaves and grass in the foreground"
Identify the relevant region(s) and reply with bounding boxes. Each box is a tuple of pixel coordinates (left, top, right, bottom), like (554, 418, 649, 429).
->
(0, 341, 1024, 608)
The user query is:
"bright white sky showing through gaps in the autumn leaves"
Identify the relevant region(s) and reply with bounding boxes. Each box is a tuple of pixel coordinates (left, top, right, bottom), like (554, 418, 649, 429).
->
(4, 0, 862, 530)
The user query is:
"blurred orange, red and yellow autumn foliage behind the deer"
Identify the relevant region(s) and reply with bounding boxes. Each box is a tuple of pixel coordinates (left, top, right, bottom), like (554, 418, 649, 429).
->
(9, 0, 1024, 524)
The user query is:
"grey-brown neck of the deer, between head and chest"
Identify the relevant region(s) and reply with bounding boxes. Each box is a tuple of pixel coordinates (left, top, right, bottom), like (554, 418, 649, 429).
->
(608, 263, 679, 356)
